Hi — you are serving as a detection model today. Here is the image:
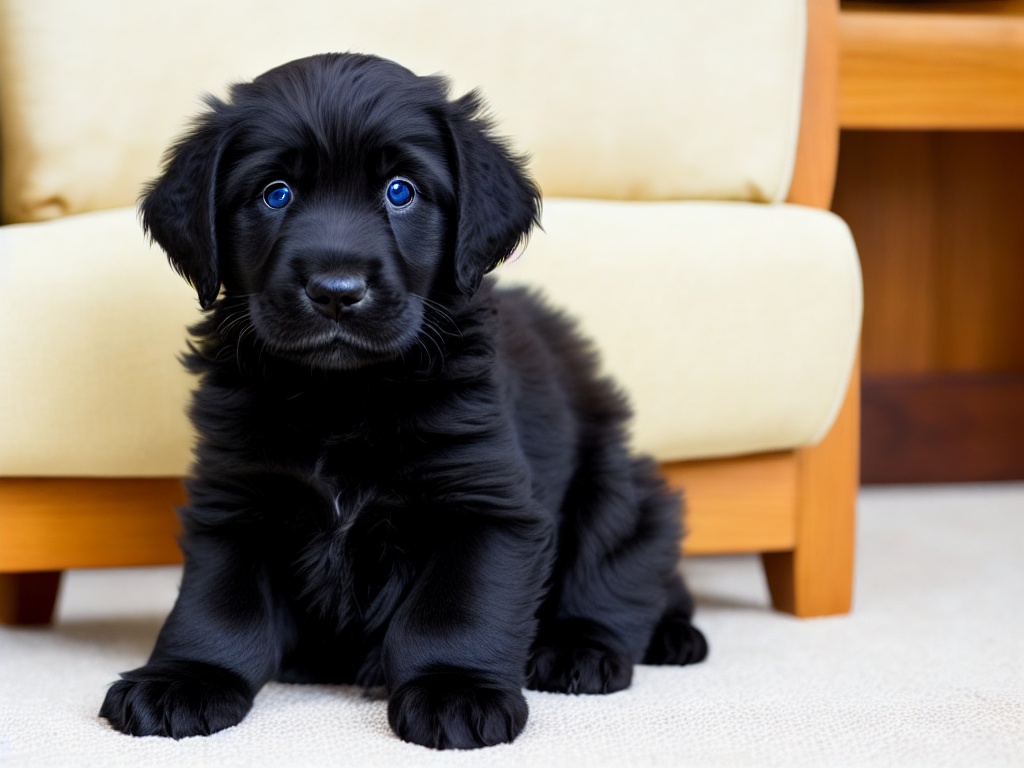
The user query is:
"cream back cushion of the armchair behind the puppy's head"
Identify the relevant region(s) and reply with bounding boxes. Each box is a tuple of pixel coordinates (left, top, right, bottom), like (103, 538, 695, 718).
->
(0, 0, 805, 222)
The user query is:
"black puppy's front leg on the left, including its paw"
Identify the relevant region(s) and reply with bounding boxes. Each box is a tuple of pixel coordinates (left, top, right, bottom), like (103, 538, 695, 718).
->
(99, 534, 284, 738)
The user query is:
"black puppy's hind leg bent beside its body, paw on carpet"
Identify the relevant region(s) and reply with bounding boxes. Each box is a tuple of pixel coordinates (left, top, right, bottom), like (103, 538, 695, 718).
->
(527, 454, 707, 693)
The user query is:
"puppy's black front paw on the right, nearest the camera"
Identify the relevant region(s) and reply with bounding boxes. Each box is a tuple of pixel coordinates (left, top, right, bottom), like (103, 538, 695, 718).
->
(387, 672, 528, 750)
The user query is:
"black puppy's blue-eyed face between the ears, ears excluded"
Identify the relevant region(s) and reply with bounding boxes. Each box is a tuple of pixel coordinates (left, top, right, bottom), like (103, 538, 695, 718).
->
(218, 58, 455, 368)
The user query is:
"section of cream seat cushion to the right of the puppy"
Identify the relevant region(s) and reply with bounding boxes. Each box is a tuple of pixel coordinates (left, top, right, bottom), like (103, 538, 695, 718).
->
(500, 200, 862, 460)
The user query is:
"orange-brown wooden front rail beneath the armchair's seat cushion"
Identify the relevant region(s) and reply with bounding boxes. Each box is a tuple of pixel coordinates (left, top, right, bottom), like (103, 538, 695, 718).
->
(0, 462, 796, 572)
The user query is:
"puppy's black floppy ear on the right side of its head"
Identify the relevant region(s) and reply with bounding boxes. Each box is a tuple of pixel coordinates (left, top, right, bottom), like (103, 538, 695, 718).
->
(449, 92, 541, 296)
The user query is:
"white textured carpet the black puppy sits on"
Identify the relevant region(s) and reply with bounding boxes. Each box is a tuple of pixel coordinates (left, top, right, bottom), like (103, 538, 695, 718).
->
(0, 483, 1024, 768)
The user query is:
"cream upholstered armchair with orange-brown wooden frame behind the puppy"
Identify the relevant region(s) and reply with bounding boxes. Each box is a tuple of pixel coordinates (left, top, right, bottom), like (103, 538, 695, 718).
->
(0, 0, 861, 622)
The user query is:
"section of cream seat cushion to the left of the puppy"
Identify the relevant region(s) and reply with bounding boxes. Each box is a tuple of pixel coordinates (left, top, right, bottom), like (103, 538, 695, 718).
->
(0, 208, 199, 477)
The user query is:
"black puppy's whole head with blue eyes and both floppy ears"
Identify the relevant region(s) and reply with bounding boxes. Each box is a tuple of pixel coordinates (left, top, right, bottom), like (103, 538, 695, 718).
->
(142, 54, 538, 370)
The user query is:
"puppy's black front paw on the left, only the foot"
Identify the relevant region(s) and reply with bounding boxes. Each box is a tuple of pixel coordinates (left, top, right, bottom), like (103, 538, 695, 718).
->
(99, 662, 253, 738)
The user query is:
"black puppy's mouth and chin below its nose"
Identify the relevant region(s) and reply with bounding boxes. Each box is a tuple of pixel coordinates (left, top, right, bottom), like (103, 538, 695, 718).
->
(249, 297, 423, 371)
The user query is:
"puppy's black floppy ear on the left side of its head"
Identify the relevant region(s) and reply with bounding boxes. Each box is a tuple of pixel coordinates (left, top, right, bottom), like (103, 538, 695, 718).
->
(139, 98, 228, 309)
